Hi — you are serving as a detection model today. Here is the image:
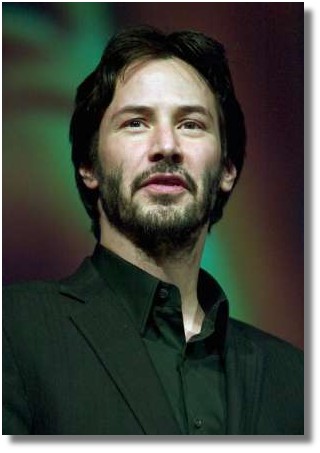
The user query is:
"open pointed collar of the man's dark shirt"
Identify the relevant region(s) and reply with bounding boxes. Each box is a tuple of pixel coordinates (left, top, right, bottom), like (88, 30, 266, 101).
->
(92, 244, 229, 350)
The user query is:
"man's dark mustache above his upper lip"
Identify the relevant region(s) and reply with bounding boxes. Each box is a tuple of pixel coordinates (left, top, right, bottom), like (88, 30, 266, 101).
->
(131, 161, 198, 195)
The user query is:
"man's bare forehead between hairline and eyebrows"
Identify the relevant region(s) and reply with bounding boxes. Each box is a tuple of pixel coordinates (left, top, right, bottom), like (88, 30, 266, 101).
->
(110, 57, 216, 109)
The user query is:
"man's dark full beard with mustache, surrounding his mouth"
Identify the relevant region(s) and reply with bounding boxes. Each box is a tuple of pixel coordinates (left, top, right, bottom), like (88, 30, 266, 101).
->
(95, 161, 221, 259)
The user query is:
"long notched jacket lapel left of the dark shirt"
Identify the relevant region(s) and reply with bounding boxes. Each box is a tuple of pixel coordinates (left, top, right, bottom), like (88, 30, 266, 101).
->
(61, 260, 181, 434)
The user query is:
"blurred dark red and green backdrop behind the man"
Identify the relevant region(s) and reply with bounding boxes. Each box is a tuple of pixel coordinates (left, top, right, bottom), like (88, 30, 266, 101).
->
(2, 2, 304, 347)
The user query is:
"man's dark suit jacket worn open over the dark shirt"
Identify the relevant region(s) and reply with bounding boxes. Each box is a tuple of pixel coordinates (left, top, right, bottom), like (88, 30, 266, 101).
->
(2, 259, 303, 435)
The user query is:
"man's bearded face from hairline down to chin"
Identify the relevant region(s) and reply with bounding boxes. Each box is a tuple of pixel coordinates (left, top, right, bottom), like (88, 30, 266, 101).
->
(81, 58, 236, 253)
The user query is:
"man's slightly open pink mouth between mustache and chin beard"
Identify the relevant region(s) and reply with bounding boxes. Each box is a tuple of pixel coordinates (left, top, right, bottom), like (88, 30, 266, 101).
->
(141, 173, 189, 194)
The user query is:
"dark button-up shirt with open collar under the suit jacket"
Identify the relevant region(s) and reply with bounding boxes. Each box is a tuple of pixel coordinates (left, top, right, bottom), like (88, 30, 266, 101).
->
(92, 245, 228, 435)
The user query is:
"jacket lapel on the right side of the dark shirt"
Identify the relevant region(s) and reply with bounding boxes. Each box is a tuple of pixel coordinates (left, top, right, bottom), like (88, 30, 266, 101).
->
(226, 325, 264, 434)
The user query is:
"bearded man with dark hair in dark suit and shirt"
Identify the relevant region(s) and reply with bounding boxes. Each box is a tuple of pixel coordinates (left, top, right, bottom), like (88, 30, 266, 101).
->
(3, 27, 303, 435)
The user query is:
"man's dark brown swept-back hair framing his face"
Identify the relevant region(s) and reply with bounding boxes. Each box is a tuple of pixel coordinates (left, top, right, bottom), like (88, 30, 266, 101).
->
(70, 26, 246, 239)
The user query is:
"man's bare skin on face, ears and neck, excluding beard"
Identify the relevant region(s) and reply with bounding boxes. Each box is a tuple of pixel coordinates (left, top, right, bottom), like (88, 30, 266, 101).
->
(80, 58, 236, 340)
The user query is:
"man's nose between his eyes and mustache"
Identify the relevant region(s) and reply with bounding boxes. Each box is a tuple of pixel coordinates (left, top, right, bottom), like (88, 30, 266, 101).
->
(149, 125, 183, 164)
